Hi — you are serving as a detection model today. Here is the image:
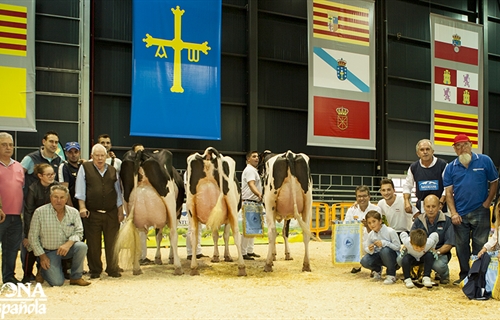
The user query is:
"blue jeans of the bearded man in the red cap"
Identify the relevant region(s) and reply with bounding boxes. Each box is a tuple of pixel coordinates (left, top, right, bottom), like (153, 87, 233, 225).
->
(453, 206, 490, 279)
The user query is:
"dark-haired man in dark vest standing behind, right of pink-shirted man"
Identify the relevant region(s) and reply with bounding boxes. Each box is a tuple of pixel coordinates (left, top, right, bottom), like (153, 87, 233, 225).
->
(21, 131, 62, 197)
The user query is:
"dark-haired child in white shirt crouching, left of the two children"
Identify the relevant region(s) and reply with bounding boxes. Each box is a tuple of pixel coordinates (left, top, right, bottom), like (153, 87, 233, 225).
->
(361, 210, 401, 284)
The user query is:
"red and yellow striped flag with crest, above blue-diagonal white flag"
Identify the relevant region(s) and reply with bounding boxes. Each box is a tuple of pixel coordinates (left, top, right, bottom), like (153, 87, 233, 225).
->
(313, 0, 370, 46)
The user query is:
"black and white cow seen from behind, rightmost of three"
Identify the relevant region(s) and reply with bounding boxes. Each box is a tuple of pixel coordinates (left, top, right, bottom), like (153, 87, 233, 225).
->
(263, 151, 312, 272)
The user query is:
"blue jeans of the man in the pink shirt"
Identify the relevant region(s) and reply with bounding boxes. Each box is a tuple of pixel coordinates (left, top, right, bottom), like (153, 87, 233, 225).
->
(0, 214, 23, 283)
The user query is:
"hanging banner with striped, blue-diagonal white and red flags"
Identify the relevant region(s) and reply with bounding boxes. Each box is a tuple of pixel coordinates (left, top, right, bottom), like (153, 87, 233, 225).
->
(307, 0, 376, 149)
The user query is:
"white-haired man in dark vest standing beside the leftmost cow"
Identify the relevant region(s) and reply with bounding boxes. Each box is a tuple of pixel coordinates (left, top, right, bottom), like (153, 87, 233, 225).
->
(75, 144, 123, 279)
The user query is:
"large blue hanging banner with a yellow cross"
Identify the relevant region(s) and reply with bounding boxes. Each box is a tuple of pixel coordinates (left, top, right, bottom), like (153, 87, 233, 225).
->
(130, 0, 222, 140)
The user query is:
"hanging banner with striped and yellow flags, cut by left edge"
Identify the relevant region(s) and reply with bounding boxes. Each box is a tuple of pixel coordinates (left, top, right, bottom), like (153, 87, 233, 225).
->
(0, 0, 36, 132)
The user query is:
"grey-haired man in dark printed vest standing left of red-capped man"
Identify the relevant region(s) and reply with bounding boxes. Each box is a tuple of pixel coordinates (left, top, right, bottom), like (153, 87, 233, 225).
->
(403, 139, 446, 213)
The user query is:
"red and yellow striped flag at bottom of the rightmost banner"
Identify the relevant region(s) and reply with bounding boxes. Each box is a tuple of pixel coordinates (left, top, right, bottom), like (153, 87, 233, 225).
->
(434, 110, 478, 148)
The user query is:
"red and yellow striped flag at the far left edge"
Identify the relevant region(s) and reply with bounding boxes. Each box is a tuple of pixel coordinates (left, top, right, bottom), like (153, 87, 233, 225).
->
(0, 3, 28, 57)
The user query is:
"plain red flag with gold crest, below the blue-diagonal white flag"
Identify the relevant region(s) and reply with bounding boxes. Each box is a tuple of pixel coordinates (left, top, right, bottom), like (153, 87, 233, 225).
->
(314, 96, 370, 140)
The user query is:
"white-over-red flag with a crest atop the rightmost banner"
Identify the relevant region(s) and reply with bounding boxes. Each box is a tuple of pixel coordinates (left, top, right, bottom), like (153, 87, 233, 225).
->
(434, 23, 479, 66)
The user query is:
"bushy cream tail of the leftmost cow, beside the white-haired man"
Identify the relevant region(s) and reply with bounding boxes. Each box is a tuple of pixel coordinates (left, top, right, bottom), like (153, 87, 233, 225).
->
(114, 176, 141, 268)
